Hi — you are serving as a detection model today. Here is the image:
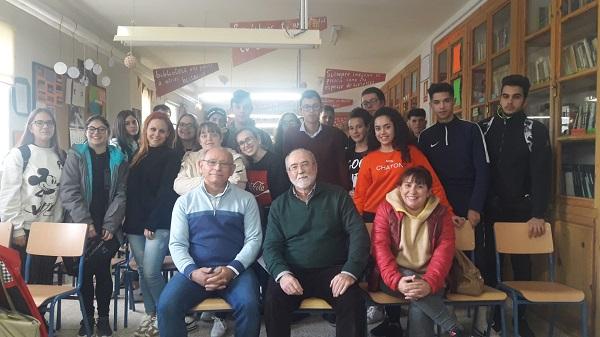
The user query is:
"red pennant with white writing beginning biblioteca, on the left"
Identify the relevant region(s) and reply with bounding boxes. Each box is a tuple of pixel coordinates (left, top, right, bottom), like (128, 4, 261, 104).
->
(153, 63, 219, 96)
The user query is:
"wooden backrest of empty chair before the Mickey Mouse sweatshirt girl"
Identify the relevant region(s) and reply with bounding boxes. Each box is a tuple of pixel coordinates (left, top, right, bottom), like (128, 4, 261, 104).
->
(27, 222, 87, 256)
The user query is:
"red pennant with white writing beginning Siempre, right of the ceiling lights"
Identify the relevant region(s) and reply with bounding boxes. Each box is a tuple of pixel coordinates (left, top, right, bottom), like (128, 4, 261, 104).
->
(323, 69, 385, 95)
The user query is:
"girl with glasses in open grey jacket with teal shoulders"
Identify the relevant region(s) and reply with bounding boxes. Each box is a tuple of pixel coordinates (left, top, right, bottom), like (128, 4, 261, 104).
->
(60, 115, 128, 337)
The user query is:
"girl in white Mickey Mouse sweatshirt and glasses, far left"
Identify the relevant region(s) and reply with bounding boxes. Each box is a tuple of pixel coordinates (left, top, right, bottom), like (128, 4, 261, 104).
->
(0, 108, 65, 284)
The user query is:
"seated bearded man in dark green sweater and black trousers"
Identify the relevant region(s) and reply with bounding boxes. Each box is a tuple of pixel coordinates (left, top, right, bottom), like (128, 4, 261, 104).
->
(263, 149, 369, 337)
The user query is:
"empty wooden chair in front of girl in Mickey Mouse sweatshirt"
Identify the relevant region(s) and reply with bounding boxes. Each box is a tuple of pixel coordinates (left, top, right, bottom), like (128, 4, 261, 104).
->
(25, 222, 92, 337)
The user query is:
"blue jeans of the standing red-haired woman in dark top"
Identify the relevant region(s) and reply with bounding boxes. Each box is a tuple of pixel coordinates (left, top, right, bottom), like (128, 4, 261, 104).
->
(127, 229, 169, 315)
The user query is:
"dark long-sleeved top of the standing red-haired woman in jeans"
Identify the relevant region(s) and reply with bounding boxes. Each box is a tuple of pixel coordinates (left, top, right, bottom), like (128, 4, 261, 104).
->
(123, 146, 181, 235)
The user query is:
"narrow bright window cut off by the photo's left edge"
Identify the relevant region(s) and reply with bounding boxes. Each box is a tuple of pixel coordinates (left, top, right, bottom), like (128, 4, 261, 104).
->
(0, 22, 15, 158)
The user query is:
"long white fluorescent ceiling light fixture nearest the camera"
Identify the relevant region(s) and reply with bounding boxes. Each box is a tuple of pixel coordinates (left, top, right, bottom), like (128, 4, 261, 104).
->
(114, 26, 321, 49)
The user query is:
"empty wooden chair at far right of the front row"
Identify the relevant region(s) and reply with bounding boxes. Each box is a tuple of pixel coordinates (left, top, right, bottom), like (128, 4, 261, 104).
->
(494, 222, 588, 337)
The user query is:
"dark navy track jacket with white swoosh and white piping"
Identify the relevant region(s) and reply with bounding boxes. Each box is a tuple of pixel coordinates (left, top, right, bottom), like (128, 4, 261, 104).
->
(419, 118, 489, 216)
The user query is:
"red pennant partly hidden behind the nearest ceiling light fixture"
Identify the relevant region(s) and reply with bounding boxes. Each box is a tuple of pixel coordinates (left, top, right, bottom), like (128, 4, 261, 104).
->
(230, 16, 327, 67)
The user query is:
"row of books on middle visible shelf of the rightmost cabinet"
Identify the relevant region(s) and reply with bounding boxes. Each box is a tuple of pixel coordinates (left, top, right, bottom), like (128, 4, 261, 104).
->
(561, 101, 596, 136)
